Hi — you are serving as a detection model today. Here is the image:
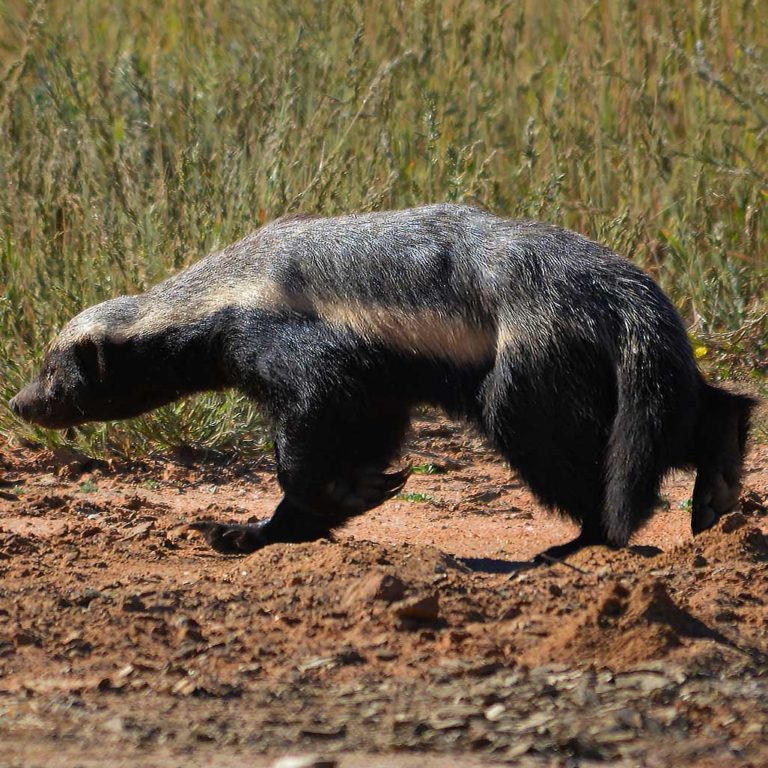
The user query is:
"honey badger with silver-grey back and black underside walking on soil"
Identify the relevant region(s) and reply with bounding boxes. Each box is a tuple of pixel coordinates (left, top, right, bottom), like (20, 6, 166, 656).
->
(11, 204, 754, 557)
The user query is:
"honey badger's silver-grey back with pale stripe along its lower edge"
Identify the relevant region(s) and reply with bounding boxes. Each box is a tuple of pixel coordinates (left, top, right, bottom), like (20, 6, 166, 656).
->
(142, 204, 660, 362)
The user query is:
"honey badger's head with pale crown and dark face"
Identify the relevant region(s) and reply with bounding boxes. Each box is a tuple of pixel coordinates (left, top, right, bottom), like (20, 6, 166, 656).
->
(10, 296, 213, 429)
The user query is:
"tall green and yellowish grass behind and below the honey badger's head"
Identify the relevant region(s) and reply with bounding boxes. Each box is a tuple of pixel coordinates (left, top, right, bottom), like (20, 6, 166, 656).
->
(0, 0, 768, 454)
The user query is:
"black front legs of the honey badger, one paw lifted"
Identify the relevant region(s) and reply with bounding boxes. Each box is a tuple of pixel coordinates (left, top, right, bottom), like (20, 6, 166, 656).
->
(191, 392, 410, 554)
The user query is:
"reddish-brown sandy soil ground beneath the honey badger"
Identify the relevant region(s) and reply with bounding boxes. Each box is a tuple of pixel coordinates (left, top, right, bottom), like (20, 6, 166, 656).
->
(0, 418, 768, 768)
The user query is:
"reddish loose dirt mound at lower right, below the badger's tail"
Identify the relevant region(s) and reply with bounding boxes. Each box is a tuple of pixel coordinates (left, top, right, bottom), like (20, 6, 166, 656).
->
(522, 577, 707, 668)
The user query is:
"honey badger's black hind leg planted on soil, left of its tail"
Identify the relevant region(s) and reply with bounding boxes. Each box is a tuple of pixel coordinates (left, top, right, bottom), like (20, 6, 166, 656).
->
(482, 344, 616, 562)
